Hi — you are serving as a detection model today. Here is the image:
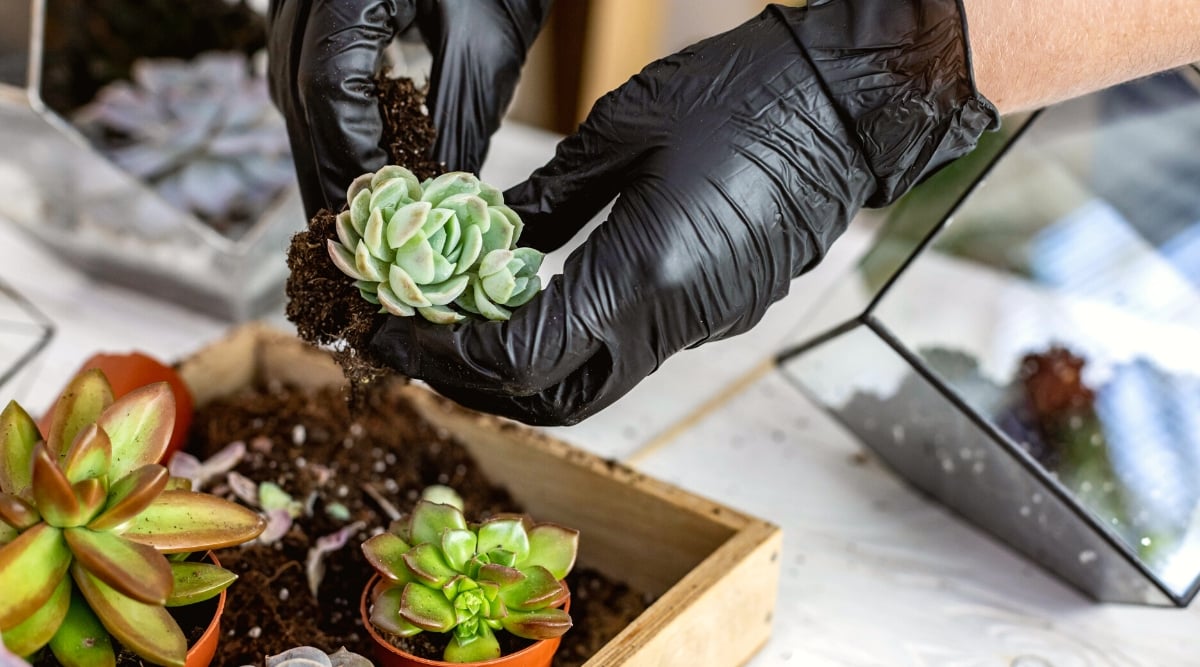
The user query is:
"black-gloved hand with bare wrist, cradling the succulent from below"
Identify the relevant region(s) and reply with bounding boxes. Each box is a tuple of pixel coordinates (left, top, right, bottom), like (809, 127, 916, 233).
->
(371, 0, 997, 425)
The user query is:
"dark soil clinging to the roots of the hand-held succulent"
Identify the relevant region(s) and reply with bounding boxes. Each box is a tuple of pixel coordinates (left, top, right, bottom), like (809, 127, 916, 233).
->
(287, 74, 445, 392)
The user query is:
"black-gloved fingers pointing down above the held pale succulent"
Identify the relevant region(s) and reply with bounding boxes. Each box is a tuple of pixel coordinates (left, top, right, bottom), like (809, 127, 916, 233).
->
(266, 0, 551, 217)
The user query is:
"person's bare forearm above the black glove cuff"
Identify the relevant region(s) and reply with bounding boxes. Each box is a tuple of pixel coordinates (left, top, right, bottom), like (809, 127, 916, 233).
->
(962, 0, 1200, 114)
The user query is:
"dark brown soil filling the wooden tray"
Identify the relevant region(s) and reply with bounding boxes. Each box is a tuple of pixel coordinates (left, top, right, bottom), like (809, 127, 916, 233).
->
(188, 371, 650, 667)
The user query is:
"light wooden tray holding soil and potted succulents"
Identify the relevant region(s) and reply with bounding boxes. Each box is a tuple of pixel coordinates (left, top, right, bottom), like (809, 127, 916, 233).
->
(180, 324, 781, 667)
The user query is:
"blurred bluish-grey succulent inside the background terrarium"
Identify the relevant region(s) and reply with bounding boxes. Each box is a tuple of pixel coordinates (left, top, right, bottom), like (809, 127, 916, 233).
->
(73, 53, 294, 236)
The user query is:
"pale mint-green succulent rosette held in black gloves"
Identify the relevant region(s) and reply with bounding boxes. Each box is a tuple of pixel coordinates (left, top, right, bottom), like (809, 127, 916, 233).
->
(328, 166, 542, 324)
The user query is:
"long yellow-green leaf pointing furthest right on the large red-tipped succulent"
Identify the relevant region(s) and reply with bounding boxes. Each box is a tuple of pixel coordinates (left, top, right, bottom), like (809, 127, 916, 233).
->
(124, 491, 266, 553)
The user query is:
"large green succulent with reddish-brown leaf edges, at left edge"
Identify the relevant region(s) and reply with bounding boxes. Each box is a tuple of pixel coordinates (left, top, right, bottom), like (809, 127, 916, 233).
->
(0, 369, 264, 667)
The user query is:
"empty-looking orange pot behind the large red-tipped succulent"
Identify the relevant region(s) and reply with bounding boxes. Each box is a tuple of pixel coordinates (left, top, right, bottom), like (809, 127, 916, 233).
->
(37, 351, 193, 464)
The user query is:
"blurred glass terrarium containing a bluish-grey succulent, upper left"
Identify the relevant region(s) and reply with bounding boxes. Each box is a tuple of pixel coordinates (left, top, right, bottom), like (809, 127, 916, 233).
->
(0, 0, 305, 320)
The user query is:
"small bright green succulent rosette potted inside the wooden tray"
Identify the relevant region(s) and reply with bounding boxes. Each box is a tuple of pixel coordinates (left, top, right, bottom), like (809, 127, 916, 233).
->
(362, 500, 580, 662)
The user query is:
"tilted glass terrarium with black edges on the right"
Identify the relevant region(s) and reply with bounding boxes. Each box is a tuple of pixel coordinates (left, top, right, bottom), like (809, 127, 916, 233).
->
(779, 67, 1200, 606)
